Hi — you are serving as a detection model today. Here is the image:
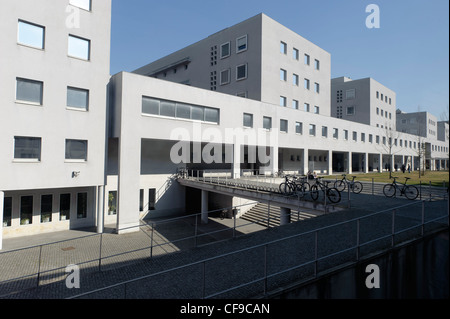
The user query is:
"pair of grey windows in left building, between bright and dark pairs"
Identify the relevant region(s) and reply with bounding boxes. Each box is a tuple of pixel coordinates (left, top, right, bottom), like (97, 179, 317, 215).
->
(16, 78, 89, 111)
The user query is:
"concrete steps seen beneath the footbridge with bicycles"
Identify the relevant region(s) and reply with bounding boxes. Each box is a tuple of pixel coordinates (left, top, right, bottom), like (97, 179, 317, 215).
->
(240, 203, 319, 227)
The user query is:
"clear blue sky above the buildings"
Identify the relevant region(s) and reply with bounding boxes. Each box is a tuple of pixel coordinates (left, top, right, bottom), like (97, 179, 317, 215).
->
(111, 0, 449, 120)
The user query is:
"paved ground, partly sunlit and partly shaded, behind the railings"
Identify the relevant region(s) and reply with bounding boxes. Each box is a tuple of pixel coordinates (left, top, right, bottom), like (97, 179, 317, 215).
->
(0, 194, 448, 299)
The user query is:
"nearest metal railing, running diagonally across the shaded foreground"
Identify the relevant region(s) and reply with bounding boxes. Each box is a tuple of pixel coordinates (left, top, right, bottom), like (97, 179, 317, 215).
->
(70, 201, 449, 299)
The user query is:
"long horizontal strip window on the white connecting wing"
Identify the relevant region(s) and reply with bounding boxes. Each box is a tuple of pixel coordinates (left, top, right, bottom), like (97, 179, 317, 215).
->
(142, 96, 220, 124)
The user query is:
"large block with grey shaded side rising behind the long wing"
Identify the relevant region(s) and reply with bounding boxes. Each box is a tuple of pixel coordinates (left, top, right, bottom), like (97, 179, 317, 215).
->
(134, 14, 331, 116)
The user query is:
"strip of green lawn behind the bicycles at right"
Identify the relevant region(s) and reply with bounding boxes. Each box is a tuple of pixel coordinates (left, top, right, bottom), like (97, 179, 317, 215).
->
(325, 170, 449, 187)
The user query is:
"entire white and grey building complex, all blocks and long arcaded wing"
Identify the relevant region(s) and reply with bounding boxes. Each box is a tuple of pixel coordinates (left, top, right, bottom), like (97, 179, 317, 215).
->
(0, 0, 449, 249)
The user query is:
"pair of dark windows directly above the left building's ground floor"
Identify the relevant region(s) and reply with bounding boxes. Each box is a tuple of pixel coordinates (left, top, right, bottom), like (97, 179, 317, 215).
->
(14, 136, 88, 162)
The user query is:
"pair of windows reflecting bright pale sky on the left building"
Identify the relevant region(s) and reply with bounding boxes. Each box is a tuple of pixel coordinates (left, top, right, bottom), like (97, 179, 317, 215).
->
(17, 20, 91, 61)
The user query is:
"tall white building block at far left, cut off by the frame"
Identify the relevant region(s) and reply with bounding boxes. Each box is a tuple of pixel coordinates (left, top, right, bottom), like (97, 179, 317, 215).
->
(0, 0, 111, 248)
